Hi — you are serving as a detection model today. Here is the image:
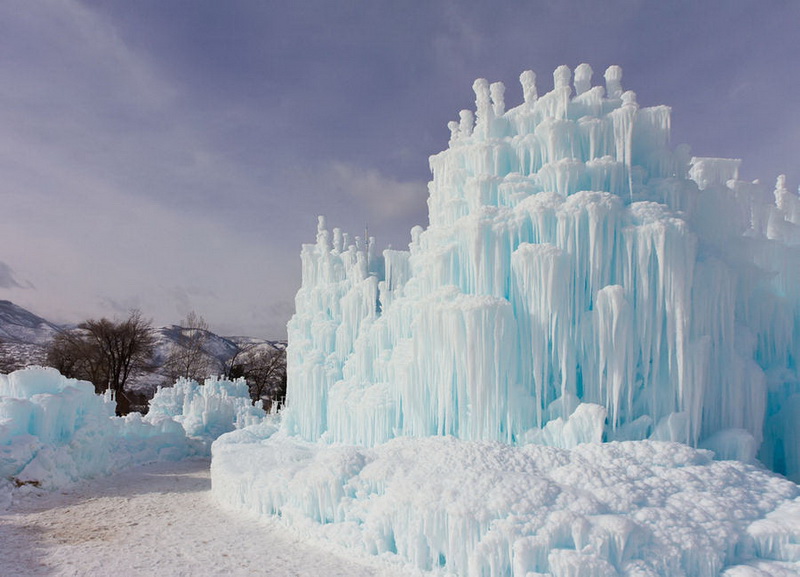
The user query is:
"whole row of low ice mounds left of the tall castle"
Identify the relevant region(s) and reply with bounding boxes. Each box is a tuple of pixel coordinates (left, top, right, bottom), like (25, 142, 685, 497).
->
(0, 368, 265, 507)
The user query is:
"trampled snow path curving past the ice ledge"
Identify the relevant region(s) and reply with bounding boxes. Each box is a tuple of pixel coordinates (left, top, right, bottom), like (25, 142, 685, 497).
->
(0, 459, 407, 577)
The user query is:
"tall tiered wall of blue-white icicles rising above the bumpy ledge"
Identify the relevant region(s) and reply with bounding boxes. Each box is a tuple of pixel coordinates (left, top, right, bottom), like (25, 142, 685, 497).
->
(284, 65, 800, 479)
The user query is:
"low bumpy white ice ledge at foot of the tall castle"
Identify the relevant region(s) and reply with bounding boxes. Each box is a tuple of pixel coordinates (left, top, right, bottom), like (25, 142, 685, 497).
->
(211, 432, 800, 577)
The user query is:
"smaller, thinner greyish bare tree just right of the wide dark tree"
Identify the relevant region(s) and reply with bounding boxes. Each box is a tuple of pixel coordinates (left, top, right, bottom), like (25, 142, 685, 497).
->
(163, 311, 214, 382)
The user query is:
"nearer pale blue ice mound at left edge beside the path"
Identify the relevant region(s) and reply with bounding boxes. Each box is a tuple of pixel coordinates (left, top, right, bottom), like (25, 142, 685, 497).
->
(0, 368, 190, 498)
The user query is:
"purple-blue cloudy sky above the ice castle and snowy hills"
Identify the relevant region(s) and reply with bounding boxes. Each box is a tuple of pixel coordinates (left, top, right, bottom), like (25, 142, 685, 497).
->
(0, 0, 800, 338)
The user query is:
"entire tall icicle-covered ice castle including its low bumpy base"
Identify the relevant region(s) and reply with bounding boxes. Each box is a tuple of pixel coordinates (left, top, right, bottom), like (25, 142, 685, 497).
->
(212, 64, 800, 577)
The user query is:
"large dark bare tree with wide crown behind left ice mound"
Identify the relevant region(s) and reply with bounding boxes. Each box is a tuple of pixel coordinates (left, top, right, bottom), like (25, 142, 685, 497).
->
(47, 310, 155, 415)
